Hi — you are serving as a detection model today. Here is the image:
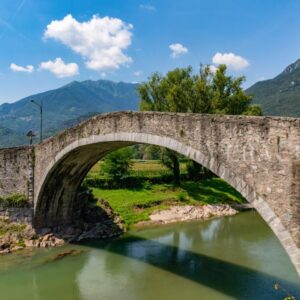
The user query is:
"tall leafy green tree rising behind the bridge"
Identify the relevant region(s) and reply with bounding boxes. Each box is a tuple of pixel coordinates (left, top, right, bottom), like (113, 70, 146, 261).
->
(138, 65, 262, 184)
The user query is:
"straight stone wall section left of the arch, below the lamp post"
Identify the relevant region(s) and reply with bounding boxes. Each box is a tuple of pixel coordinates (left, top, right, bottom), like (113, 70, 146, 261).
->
(0, 147, 34, 203)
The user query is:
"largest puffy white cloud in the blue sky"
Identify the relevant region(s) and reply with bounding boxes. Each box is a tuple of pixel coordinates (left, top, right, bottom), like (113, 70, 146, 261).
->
(44, 15, 133, 71)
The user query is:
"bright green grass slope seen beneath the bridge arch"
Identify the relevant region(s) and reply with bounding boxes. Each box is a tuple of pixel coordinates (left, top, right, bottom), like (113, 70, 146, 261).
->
(93, 178, 245, 227)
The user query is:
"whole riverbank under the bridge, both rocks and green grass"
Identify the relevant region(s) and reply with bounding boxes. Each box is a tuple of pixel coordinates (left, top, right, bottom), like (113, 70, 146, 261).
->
(0, 178, 245, 254)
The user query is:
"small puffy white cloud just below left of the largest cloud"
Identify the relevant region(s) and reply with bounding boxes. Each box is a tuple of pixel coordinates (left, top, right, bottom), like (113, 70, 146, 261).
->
(40, 57, 79, 78)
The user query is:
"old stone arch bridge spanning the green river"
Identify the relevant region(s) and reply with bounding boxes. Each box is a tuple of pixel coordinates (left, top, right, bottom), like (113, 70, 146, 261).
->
(0, 112, 300, 274)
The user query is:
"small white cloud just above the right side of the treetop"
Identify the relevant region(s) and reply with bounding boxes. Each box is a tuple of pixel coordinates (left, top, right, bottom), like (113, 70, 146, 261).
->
(212, 52, 250, 71)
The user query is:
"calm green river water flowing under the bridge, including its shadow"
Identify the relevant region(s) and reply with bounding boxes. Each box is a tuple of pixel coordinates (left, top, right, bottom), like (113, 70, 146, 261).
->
(0, 212, 300, 300)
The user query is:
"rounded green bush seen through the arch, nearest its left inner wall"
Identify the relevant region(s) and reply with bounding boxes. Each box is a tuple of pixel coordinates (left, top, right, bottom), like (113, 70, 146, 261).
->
(102, 147, 132, 183)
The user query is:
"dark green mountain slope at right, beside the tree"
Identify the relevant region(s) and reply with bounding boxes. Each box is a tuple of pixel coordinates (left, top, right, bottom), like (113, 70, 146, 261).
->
(246, 59, 300, 117)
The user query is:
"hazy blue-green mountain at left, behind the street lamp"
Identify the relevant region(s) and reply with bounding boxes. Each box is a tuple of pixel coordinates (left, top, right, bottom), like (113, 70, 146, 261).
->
(0, 80, 139, 148)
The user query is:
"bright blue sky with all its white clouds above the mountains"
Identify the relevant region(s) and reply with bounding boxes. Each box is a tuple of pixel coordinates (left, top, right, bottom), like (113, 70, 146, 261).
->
(0, 0, 300, 104)
